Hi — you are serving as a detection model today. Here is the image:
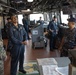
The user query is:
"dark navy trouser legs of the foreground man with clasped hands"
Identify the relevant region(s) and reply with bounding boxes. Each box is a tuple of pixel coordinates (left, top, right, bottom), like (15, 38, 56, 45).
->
(10, 45, 25, 75)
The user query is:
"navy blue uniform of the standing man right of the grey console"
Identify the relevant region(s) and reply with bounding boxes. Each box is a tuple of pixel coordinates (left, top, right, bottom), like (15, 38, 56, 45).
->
(48, 21, 58, 50)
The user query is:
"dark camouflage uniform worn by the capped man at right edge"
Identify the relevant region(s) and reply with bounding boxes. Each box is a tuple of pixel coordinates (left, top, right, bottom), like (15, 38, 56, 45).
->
(61, 28, 76, 56)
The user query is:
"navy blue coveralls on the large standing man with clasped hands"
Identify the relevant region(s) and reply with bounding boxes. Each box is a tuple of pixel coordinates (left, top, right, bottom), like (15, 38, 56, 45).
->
(8, 24, 26, 75)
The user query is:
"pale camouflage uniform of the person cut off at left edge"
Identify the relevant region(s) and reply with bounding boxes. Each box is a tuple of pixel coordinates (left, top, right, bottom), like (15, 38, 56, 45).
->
(0, 39, 6, 75)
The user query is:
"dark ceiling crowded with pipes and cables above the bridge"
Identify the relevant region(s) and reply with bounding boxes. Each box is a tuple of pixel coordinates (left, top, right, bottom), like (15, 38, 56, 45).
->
(0, 0, 76, 12)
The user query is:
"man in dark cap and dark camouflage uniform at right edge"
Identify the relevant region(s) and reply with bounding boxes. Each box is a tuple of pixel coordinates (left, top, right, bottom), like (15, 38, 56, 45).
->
(59, 17, 76, 56)
